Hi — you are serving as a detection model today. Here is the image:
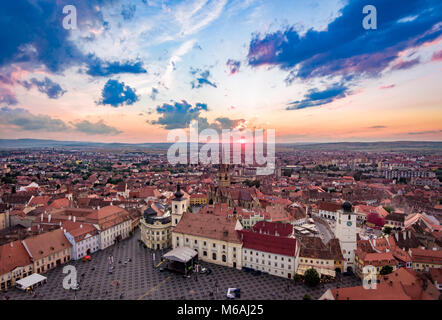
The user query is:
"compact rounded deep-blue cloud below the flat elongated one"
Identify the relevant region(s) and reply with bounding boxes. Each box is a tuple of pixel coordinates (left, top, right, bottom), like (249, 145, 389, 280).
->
(98, 79, 139, 108)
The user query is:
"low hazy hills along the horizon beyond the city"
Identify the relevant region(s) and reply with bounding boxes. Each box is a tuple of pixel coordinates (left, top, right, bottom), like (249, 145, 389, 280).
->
(0, 139, 442, 152)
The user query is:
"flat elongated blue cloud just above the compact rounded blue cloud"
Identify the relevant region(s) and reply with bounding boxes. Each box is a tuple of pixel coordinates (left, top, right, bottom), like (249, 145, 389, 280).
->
(86, 56, 147, 77)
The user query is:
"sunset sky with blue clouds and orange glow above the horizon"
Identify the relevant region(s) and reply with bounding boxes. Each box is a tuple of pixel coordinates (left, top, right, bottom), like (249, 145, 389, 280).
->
(0, 0, 442, 143)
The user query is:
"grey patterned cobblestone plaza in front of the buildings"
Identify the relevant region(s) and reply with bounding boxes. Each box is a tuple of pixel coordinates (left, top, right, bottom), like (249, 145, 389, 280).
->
(0, 232, 361, 300)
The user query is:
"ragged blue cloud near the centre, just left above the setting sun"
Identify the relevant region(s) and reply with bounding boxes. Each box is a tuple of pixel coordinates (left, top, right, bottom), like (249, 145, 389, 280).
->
(148, 100, 208, 130)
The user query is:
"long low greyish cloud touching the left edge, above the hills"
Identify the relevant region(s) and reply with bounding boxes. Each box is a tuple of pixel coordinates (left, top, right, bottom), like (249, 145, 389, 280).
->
(0, 107, 69, 132)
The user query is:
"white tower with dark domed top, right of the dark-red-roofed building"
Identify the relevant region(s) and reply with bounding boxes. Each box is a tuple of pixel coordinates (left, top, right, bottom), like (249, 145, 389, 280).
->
(335, 201, 357, 271)
